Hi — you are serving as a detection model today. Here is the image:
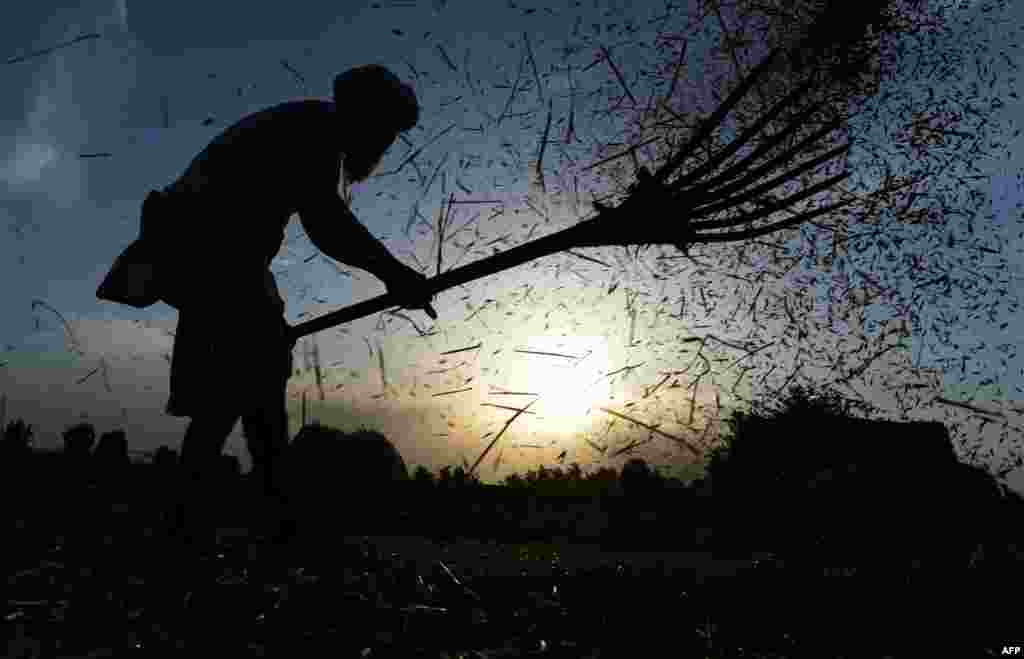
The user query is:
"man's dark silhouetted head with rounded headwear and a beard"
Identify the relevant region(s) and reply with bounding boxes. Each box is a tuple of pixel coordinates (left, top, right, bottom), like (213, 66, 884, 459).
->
(334, 64, 420, 181)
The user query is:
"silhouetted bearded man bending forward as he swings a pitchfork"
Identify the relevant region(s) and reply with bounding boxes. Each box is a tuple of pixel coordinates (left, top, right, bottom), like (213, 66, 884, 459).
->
(152, 65, 436, 539)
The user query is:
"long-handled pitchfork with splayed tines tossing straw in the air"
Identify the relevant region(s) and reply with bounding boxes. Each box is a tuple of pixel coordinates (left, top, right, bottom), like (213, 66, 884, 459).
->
(291, 48, 855, 340)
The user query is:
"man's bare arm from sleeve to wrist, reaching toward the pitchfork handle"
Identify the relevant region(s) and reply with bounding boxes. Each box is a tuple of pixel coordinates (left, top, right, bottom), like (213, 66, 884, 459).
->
(299, 192, 404, 283)
